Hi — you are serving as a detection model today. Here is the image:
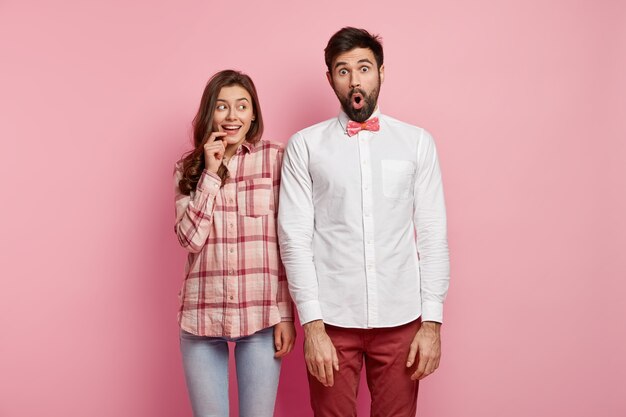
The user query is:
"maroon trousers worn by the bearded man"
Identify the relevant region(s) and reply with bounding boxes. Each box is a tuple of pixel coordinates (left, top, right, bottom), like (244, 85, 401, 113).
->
(307, 319, 421, 417)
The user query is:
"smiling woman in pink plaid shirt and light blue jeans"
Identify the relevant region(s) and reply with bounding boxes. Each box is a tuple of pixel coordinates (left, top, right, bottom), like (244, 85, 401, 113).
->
(175, 70, 295, 417)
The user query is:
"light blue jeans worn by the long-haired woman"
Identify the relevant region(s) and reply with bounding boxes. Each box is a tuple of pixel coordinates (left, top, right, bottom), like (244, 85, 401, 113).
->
(180, 327, 280, 417)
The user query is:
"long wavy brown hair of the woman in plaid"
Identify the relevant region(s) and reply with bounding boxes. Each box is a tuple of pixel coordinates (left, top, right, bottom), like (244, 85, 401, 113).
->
(178, 70, 263, 195)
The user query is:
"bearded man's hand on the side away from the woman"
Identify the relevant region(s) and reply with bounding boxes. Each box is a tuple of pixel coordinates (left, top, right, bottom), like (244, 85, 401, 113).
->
(406, 321, 441, 380)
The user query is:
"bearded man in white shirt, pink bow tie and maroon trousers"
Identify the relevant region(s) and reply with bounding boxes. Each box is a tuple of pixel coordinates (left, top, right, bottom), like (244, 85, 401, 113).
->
(279, 27, 449, 417)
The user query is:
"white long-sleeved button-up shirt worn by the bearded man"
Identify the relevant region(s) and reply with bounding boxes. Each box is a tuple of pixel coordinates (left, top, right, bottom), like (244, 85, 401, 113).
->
(278, 111, 449, 328)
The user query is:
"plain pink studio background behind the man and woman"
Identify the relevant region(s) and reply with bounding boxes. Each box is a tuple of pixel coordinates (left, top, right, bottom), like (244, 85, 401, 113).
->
(0, 0, 626, 417)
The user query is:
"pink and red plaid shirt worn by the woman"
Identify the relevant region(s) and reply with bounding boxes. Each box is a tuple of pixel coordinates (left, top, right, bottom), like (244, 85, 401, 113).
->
(175, 140, 293, 338)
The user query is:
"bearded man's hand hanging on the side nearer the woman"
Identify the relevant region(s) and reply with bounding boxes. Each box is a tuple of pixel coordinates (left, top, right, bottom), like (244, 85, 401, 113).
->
(302, 320, 339, 387)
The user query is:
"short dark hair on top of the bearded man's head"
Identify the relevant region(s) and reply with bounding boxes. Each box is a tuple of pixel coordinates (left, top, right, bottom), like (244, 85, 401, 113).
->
(324, 26, 384, 73)
